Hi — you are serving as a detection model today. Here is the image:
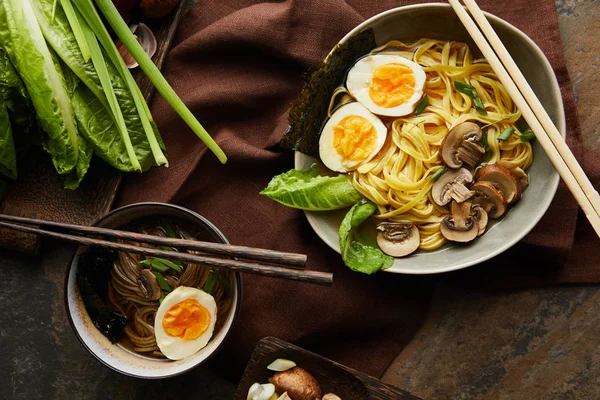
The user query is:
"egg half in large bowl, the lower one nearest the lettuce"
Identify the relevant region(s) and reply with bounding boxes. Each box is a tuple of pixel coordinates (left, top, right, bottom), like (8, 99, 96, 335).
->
(319, 103, 387, 172)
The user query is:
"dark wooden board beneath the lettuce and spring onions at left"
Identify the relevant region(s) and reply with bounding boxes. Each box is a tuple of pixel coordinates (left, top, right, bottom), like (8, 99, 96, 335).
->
(0, 0, 186, 255)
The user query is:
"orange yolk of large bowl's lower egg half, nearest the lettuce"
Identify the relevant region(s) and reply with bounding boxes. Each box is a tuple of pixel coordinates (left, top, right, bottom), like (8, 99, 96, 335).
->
(333, 115, 377, 161)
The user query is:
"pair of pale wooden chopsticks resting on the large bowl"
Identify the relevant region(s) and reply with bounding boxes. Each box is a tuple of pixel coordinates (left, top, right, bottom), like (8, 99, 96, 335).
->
(448, 0, 600, 236)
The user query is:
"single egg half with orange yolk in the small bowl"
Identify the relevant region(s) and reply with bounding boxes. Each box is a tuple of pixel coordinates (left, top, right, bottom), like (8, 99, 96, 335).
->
(154, 286, 217, 360)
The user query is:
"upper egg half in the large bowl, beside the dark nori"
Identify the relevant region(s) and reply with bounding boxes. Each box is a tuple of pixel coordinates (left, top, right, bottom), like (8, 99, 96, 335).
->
(346, 54, 426, 117)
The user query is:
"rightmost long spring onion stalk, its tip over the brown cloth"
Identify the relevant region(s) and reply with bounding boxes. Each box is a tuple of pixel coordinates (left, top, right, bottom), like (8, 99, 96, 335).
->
(94, 0, 227, 164)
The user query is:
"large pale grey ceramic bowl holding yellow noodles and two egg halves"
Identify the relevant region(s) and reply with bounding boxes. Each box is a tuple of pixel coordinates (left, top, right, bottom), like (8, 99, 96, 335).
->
(295, 4, 565, 274)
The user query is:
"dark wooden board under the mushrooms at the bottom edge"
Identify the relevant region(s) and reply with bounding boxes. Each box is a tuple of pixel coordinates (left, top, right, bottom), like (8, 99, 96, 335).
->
(233, 337, 421, 400)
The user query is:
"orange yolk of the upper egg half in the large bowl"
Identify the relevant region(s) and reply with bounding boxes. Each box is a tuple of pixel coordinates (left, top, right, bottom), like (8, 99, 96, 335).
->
(369, 63, 415, 108)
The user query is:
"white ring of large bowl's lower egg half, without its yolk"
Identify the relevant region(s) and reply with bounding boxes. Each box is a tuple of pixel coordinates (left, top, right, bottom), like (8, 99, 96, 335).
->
(319, 102, 387, 172)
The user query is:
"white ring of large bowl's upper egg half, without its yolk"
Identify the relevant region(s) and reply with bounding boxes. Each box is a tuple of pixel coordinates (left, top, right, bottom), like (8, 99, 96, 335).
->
(346, 54, 426, 117)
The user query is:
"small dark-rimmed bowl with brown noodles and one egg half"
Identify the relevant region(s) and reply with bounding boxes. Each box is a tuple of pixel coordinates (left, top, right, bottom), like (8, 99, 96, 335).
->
(65, 203, 242, 379)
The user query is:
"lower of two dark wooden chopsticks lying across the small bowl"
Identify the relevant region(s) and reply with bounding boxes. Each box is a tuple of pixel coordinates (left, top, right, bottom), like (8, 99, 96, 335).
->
(0, 222, 333, 286)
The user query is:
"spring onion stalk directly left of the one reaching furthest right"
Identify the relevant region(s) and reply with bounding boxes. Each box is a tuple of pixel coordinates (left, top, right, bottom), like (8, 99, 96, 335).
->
(68, 0, 169, 166)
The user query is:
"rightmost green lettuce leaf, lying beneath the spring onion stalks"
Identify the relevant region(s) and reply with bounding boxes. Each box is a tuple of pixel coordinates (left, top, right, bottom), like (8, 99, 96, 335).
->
(34, 0, 164, 172)
